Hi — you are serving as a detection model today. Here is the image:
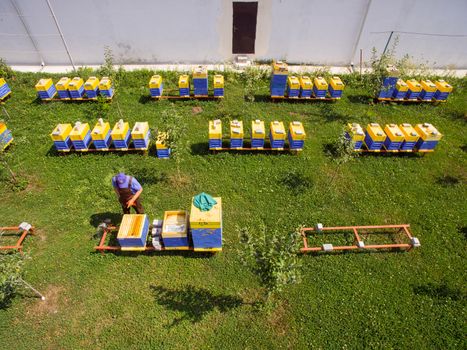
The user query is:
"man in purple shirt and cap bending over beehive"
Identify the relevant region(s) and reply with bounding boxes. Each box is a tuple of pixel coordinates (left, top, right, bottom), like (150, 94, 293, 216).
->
(112, 173, 144, 214)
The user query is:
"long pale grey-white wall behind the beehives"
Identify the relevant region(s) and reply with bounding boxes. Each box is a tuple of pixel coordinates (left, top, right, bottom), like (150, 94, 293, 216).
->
(0, 0, 467, 68)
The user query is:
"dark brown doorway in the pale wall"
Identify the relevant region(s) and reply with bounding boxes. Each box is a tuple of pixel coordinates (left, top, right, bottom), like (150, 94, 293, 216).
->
(232, 1, 258, 54)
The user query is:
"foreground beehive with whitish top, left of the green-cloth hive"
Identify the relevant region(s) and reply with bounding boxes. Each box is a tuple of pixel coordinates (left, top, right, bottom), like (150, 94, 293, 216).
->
(161, 210, 190, 250)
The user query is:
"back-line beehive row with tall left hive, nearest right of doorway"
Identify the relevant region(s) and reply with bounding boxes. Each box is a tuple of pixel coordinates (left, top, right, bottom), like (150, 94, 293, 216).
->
(269, 61, 345, 99)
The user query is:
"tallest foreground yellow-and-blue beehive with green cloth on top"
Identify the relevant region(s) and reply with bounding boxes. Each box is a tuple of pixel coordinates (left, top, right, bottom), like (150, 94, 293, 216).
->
(190, 197, 222, 252)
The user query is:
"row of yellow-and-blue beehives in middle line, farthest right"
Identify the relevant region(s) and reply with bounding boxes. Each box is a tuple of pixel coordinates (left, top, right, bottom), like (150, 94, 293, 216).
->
(345, 123, 442, 152)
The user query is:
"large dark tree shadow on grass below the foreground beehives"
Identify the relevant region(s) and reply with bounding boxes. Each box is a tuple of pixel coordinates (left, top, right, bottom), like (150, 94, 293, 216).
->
(149, 285, 244, 327)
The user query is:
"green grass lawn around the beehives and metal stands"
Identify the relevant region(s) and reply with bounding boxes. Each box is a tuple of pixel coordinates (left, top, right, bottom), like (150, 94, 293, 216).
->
(0, 71, 467, 349)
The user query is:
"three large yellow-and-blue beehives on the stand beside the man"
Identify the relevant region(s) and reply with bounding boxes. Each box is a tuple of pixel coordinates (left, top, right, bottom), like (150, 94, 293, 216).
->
(117, 197, 222, 252)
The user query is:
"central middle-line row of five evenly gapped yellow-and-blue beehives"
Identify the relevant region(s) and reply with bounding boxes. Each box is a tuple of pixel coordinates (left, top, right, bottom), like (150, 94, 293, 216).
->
(209, 119, 306, 151)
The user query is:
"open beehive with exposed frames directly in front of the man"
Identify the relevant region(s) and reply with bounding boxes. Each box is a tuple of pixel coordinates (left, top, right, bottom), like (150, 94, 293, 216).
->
(117, 214, 149, 250)
